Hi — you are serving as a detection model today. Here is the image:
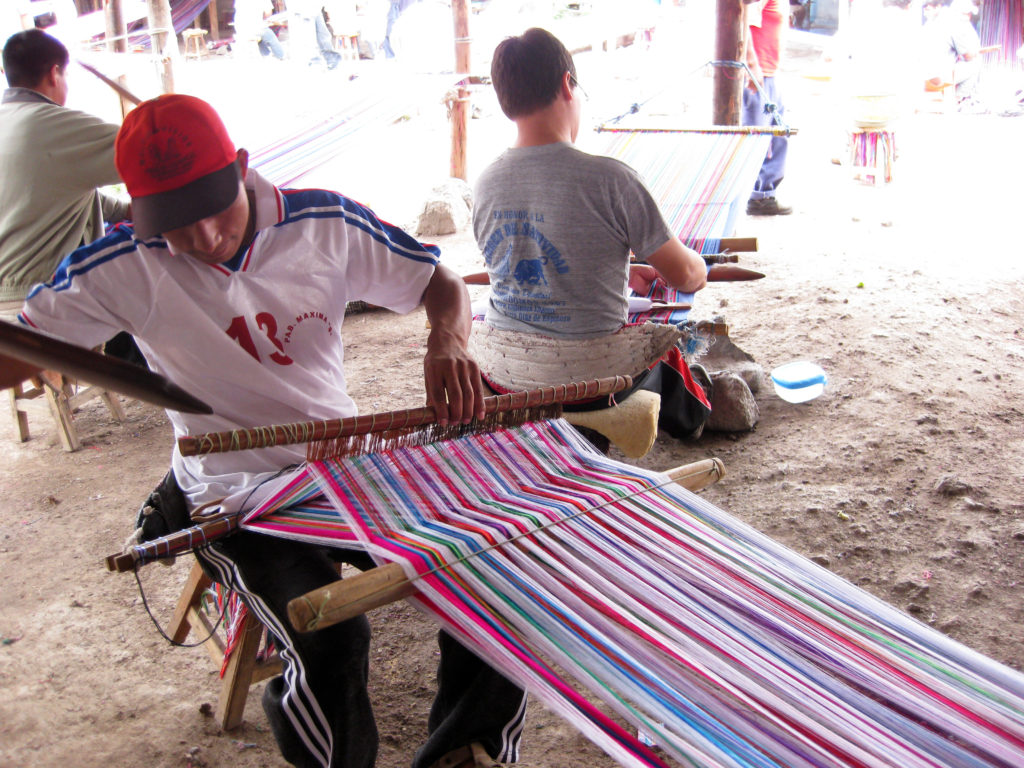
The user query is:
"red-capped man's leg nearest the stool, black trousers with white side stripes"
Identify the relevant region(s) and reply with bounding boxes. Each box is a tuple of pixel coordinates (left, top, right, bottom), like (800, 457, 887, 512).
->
(197, 532, 378, 768)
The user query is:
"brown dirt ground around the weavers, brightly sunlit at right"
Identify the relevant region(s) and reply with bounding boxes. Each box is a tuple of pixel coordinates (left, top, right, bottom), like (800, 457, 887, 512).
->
(0, 19, 1024, 768)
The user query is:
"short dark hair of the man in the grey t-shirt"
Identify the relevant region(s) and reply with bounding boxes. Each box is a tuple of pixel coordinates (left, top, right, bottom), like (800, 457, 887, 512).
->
(490, 27, 575, 120)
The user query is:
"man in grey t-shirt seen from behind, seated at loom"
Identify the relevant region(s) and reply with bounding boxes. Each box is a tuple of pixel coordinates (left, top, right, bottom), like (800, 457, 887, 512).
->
(473, 29, 710, 437)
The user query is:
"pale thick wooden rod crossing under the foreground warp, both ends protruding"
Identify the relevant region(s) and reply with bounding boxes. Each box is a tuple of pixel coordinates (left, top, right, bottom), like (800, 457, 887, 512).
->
(288, 458, 725, 632)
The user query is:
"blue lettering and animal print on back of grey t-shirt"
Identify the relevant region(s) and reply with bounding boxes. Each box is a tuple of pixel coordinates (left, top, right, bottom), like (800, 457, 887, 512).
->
(483, 210, 570, 323)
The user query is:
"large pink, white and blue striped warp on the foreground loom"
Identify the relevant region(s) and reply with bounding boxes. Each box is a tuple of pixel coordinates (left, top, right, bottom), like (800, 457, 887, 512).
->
(237, 421, 1024, 768)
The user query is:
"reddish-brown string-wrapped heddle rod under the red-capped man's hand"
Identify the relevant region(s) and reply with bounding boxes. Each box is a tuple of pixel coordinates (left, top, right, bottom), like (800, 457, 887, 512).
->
(178, 376, 633, 456)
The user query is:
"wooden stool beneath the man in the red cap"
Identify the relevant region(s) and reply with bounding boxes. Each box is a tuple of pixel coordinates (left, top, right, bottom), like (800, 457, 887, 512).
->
(170, 562, 282, 731)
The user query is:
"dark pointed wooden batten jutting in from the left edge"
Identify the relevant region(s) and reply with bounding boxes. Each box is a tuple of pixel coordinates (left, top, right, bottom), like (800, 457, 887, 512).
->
(0, 323, 213, 414)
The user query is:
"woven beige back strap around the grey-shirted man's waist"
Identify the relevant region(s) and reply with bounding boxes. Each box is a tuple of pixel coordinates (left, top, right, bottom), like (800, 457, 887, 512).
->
(469, 323, 682, 391)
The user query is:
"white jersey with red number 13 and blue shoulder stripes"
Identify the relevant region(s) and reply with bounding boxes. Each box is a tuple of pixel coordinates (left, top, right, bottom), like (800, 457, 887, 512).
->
(20, 169, 438, 506)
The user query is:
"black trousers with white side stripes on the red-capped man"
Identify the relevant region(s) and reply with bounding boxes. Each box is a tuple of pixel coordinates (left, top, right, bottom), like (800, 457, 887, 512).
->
(197, 532, 525, 768)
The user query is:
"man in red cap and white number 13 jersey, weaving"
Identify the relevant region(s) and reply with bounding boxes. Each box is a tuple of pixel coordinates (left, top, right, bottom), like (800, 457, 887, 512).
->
(0, 95, 524, 768)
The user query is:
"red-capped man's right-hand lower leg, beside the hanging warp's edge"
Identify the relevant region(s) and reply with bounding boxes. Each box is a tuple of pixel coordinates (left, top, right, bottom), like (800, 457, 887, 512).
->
(413, 631, 526, 768)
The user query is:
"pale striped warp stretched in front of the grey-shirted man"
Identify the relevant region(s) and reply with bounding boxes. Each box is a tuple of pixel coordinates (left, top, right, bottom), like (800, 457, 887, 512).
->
(600, 128, 771, 324)
